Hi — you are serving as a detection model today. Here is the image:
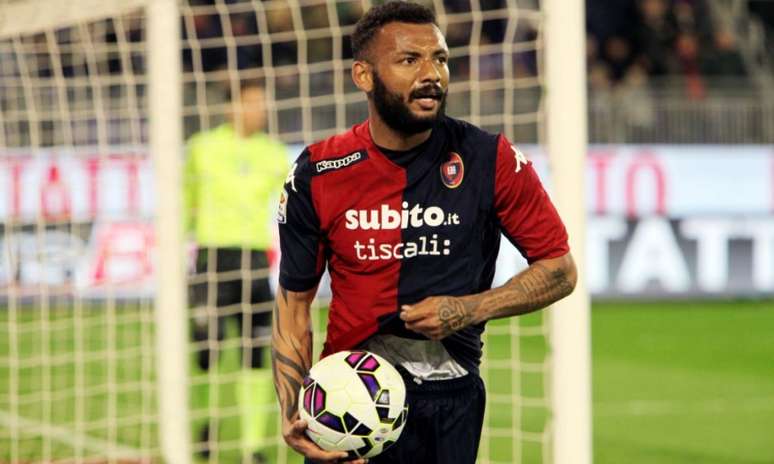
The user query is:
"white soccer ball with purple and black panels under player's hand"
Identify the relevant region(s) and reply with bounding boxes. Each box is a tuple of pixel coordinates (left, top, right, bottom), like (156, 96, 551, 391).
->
(298, 351, 408, 459)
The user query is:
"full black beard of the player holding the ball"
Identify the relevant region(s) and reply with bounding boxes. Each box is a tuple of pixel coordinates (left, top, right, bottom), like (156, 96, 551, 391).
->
(369, 71, 448, 136)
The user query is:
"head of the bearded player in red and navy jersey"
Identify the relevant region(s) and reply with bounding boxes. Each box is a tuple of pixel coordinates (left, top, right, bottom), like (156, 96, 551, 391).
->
(352, 1, 449, 135)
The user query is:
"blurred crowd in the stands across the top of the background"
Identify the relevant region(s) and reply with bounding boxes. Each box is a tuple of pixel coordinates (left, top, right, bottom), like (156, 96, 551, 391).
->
(0, 0, 774, 146)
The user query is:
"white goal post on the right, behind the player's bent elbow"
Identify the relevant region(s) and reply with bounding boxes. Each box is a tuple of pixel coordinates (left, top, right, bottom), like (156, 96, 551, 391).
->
(544, 0, 592, 464)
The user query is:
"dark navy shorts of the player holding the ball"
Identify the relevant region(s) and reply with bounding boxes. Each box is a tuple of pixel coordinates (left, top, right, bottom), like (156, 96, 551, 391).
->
(305, 374, 486, 464)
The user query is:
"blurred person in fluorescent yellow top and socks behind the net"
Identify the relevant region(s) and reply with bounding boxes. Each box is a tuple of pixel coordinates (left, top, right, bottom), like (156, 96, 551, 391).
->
(184, 80, 289, 461)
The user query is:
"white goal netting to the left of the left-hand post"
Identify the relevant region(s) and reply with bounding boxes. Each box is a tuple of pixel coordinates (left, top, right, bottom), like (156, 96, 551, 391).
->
(0, 3, 157, 462)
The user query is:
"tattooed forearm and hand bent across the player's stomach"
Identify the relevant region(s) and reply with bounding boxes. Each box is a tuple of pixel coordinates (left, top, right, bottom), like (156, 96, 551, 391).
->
(400, 253, 577, 340)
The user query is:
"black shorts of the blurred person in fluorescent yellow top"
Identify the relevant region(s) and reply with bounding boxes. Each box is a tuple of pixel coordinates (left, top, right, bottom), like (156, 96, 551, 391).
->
(189, 248, 274, 369)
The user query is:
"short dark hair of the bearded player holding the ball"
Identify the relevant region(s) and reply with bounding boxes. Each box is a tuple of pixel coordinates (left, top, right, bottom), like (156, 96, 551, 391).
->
(352, 1, 438, 60)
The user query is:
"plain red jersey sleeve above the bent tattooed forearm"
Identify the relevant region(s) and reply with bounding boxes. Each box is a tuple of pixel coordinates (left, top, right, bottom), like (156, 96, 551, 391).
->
(494, 136, 570, 263)
